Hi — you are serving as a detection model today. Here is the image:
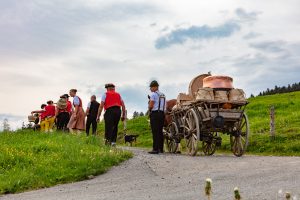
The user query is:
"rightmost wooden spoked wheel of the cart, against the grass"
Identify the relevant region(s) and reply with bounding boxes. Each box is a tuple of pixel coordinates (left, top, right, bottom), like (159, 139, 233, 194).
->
(230, 113, 250, 157)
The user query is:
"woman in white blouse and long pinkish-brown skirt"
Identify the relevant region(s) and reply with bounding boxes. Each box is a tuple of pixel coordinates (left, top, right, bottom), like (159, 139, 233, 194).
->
(67, 89, 85, 134)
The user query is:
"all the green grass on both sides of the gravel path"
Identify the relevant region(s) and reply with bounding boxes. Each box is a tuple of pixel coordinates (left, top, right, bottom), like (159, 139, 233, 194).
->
(0, 92, 300, 194)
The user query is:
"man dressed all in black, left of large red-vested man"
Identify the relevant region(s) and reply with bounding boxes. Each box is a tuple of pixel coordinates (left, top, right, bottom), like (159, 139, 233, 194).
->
(85, 95, 100, 136)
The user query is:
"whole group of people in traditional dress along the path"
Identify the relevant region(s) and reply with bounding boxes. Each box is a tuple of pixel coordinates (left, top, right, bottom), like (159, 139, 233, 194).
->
(32, 81, 166, 154)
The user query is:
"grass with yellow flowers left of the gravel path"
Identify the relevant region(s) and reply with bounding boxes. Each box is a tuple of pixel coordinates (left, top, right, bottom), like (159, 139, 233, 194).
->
(0, 131, 132, 194)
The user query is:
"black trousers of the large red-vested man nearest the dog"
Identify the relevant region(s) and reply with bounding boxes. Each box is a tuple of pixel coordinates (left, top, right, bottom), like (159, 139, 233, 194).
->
(104, 107, 121, 142)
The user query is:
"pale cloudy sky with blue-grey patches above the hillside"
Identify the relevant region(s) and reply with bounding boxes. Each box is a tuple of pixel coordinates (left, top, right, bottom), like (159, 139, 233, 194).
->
(0, 0, 300, 128)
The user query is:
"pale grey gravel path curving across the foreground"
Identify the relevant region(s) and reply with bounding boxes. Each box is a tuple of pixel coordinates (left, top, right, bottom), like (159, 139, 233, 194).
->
(0, 149, 300, 200)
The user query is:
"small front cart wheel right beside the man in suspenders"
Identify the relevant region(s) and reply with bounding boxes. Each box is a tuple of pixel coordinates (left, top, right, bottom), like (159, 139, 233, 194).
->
(165, 122, 178, 153)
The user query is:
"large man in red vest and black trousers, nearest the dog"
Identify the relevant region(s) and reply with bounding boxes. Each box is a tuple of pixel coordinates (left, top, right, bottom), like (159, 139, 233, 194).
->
(97, 83, 126, 146)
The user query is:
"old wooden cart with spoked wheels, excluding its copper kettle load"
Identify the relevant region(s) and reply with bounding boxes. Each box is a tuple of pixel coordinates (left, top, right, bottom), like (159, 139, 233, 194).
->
(165, 74, 249, 156)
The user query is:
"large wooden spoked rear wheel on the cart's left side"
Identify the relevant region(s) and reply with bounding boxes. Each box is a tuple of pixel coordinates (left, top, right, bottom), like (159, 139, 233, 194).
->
(184, 109, 199, 156)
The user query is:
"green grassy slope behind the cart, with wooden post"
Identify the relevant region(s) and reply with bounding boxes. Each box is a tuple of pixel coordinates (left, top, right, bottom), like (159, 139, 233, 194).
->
(99, 92, 300, 156)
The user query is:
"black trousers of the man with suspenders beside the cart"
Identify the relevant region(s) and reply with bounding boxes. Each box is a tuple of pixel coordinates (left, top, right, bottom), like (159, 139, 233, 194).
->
(150, 112, 165, 152)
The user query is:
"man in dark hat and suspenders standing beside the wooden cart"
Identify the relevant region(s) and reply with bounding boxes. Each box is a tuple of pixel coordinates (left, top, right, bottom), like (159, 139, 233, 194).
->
(149, 81, 166, 154)
